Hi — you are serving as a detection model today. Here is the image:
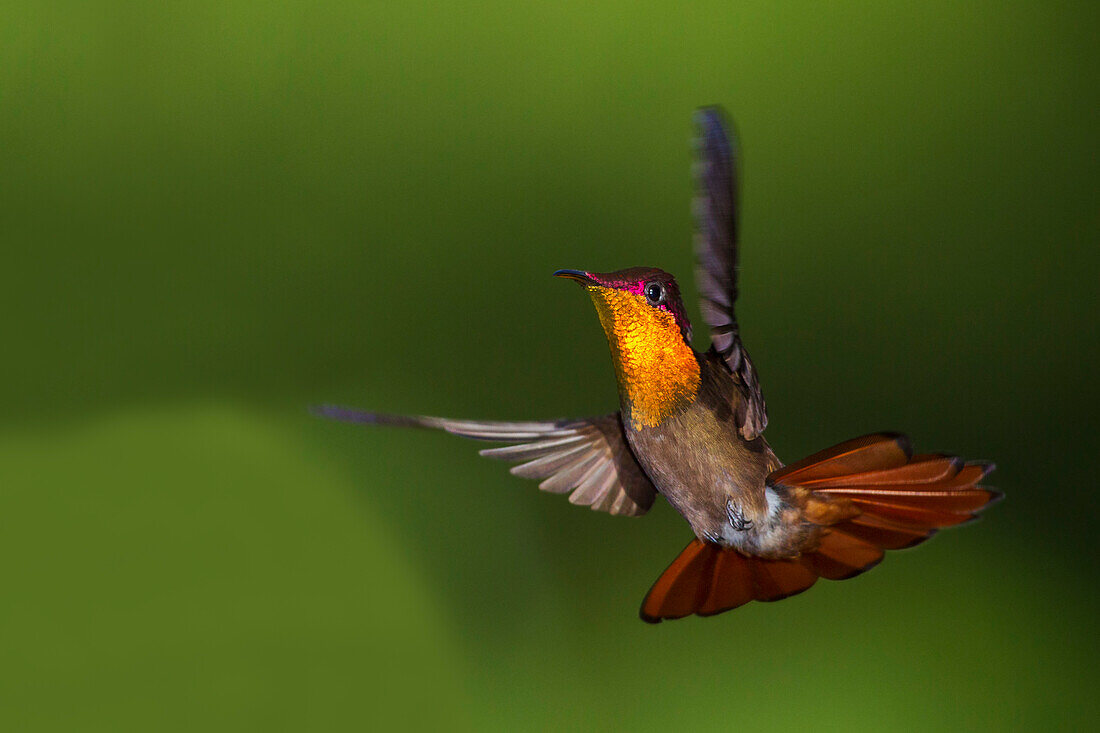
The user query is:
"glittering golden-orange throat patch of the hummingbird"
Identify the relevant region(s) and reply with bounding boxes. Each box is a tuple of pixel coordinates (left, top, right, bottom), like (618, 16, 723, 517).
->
(586, 285, 701, 428)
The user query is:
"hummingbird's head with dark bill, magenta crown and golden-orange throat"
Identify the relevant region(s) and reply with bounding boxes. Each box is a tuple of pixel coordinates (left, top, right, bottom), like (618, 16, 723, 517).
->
(554, 267, 700, 428)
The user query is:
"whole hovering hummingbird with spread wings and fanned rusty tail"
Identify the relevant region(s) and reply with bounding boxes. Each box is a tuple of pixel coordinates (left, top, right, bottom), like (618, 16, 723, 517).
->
(316, 108, 1000, 623)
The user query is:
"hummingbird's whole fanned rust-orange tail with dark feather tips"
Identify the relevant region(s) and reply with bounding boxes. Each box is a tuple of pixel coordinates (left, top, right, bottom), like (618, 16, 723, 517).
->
(641, 433, 1001, 623)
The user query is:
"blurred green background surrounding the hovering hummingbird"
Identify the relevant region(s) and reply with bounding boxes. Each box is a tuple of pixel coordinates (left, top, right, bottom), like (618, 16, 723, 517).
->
(0, 0, 1100, 731)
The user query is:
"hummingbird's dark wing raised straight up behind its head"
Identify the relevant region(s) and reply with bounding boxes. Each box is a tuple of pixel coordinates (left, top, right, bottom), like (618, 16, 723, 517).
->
(694, 107, 768, 440)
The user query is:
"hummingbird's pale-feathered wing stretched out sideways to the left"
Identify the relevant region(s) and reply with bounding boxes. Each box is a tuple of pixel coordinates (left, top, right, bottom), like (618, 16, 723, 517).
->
(314, 405, 657, 516)
